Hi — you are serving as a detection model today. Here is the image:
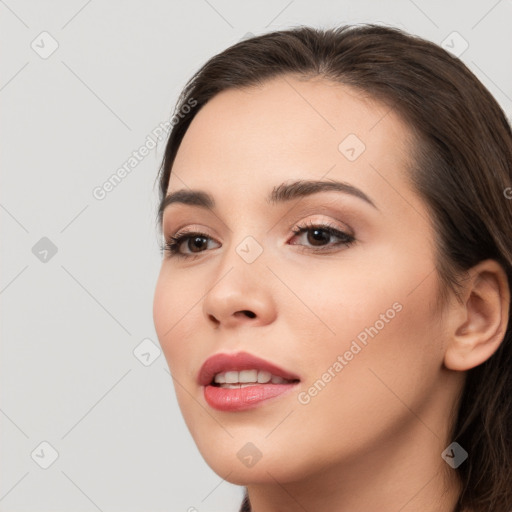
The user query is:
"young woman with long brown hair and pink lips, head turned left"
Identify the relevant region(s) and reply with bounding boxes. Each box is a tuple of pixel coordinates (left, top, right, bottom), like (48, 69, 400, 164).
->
(154, 25, 512, 512)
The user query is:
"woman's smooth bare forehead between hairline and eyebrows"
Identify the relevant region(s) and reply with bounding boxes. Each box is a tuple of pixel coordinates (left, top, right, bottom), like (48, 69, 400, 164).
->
(168, 76, 420, 217)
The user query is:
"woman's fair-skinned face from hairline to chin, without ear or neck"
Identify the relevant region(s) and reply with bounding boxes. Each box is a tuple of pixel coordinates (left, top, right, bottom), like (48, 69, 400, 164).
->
(154, 76, 460, 484)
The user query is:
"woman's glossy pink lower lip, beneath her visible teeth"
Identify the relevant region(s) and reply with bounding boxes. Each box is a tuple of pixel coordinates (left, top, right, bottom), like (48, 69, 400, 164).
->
(204, 383, 298, 411)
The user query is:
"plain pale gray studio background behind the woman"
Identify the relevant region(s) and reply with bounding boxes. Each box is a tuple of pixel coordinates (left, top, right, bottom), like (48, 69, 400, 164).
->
(0, 0, 512, 512)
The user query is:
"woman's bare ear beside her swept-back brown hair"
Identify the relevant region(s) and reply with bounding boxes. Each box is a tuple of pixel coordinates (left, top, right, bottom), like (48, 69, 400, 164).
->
(444, 260, 510, 371)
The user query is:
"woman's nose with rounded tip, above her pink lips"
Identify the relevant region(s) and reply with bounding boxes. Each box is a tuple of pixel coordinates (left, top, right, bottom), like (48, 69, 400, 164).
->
(203, 250, 277, 329)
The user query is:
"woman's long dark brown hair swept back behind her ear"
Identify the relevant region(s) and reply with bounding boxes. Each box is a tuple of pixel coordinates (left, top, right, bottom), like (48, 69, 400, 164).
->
(158, 24, 512, 512)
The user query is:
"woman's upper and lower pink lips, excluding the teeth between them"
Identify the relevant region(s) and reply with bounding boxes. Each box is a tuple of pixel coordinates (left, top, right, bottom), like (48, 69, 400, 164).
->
(197, 352, 300, 411)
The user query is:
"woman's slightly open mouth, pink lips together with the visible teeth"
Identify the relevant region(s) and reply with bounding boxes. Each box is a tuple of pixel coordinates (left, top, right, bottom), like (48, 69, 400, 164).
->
(198, 352, 300, 411)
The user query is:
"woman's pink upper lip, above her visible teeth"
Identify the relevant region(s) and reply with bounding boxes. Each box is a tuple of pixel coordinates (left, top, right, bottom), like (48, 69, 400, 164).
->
(197, 352, 300, 386)
